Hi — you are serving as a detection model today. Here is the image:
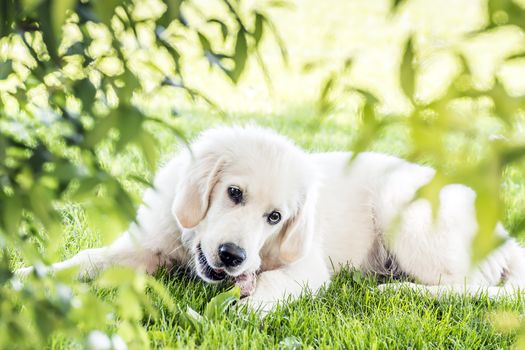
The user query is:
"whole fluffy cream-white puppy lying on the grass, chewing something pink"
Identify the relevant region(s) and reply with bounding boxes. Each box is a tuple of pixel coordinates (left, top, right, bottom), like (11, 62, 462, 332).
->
(16, 128, 525, 310)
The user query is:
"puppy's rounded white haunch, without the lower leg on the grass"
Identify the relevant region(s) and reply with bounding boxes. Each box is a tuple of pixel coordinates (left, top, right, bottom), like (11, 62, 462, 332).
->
(382, 185, 477, 285)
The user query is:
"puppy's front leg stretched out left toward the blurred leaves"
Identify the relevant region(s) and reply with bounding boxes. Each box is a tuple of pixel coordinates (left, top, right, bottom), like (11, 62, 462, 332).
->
(16, 159, 184, 279)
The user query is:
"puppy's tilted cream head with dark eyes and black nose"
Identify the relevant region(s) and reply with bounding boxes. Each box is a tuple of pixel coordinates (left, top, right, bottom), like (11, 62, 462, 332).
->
(172, 127, 316, 282)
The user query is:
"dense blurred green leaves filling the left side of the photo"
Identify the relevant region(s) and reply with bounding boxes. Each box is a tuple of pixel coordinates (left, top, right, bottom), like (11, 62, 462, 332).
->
(0, 0, 285, 349)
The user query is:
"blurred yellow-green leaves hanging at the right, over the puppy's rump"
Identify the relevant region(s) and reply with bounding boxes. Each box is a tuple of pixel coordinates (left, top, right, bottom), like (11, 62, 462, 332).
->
(318, 0, 525, 261)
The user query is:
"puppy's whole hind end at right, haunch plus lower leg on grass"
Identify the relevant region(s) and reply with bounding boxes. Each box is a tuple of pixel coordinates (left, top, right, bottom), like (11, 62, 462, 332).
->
(374, 185, 525, 298)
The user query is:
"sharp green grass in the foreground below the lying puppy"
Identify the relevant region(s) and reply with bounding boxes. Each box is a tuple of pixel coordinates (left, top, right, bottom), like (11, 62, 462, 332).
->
(141, 270, 522, 349)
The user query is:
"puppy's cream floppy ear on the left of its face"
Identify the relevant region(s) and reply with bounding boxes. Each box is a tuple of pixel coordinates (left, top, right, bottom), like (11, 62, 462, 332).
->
(171, 152, 223, 228)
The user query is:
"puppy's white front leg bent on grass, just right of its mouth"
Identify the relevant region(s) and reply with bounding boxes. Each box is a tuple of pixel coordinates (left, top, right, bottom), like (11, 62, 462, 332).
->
(241, 248, 330, 314)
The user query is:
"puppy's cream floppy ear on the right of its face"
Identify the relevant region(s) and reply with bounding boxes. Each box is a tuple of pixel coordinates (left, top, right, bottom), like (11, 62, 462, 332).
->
(279, 190, 317, 263)
